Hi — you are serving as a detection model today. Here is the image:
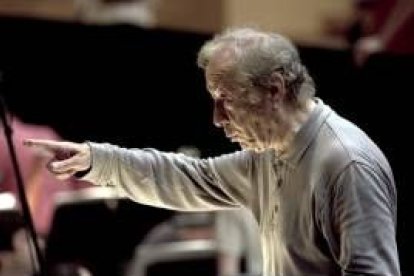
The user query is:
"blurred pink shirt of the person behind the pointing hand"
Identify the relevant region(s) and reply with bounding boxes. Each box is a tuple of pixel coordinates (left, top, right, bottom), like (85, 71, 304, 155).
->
(0, 113, 66, 236)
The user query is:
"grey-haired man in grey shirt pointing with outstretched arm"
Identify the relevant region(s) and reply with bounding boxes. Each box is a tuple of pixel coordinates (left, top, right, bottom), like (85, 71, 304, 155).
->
(26, 29, 400, 276)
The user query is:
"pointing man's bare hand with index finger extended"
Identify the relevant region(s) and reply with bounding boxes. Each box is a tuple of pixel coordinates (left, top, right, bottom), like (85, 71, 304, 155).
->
(23, 139, 92, 180)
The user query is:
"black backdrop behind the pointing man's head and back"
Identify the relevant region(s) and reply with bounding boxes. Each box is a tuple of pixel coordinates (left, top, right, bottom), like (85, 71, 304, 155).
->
(0, 18, 414, 275)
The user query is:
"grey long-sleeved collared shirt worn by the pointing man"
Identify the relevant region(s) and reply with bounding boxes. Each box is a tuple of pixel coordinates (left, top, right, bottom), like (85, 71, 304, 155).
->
(84, 99, 400, 276)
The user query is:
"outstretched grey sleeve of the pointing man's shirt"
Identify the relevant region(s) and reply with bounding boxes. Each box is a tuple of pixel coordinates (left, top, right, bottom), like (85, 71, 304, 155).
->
(83, 143, 253, 211)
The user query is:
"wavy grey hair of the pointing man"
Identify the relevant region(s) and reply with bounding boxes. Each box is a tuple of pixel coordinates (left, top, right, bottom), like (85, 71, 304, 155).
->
(197, 28, 315, 104)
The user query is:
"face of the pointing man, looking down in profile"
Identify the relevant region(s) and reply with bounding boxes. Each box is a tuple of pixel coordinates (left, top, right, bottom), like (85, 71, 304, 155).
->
(205, 51, 272, 150)
